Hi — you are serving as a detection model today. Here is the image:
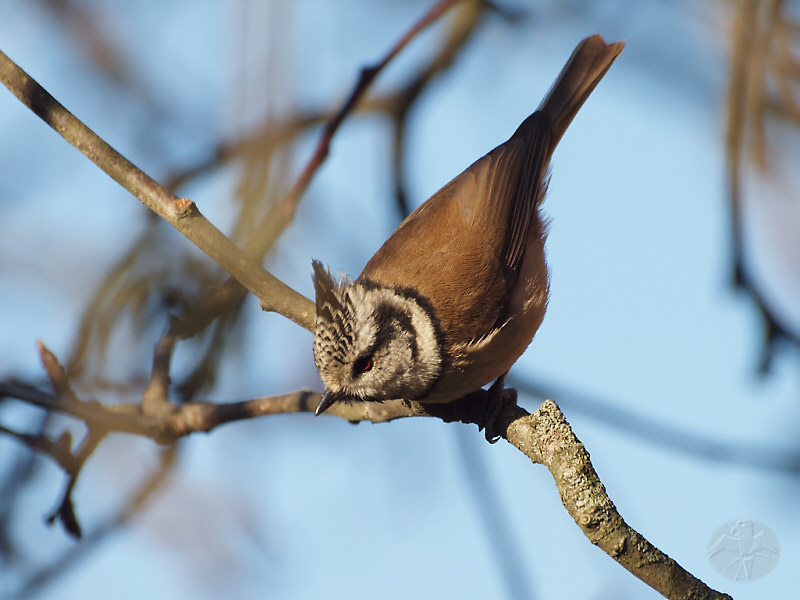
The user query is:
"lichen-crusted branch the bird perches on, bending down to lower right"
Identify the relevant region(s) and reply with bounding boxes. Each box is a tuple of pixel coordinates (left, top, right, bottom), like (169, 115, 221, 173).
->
(0, 356, 730, 600)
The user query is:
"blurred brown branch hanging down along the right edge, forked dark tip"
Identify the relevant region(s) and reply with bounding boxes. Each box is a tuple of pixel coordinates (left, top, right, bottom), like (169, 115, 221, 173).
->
(725, 0, 800, 374)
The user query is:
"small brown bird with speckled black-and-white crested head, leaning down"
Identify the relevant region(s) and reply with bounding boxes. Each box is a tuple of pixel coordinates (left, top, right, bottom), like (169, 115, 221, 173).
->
(313, 35, 624, 414)
